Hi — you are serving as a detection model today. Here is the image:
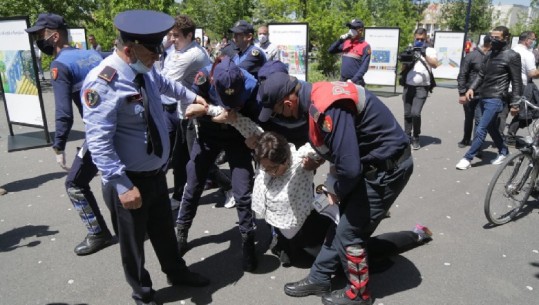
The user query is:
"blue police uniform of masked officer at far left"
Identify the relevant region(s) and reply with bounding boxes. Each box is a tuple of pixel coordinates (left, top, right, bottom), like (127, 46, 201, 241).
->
(51, 47, 112, 248)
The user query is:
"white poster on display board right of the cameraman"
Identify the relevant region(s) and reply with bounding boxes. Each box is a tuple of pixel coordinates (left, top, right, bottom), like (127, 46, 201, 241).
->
(432, 31, 465, 80)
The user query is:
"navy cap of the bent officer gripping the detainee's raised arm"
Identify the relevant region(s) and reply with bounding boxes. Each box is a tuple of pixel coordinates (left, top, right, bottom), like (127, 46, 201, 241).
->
(213, 57, 244, 108)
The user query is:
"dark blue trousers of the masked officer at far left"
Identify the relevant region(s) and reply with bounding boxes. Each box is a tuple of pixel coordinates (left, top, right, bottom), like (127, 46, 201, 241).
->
(65, 144, 112, 234)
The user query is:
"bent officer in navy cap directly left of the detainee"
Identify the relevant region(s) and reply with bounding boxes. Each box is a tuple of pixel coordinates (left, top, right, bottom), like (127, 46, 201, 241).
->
(176, 56, 260, 271)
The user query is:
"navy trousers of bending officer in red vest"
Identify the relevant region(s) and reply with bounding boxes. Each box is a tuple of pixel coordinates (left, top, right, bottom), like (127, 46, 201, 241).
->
(309, 157, 413, 283)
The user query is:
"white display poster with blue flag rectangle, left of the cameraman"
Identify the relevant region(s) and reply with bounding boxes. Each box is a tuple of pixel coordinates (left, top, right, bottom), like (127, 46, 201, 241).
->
(363, 28, 400, 86)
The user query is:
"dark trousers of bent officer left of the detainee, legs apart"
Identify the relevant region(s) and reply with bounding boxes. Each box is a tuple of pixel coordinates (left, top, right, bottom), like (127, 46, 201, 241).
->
(177, 122, 254, 233)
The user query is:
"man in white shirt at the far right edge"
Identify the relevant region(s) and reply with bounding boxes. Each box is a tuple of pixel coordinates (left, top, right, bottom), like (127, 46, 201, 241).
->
(506, 31, 539, 146)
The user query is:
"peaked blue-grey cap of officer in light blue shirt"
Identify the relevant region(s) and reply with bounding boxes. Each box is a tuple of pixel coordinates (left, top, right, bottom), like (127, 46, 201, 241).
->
(114, 10, 174, 53)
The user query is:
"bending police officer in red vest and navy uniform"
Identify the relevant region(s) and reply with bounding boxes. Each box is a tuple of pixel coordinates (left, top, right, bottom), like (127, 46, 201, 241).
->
(259, 73, 413, 305)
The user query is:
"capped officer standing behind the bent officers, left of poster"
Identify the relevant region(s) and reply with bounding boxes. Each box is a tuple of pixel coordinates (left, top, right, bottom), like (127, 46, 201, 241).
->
(228, 20, 266, 78)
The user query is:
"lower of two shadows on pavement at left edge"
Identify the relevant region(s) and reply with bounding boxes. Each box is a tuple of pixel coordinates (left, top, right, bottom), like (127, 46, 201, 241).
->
(0, 225, 59, 252)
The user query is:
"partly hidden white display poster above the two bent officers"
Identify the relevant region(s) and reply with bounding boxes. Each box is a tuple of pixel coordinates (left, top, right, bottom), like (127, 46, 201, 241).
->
(268, 23, 309, 81)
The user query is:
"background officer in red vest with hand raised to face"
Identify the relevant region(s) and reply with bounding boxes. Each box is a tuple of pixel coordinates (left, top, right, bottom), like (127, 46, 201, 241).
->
(328, 19, 371, 86)
